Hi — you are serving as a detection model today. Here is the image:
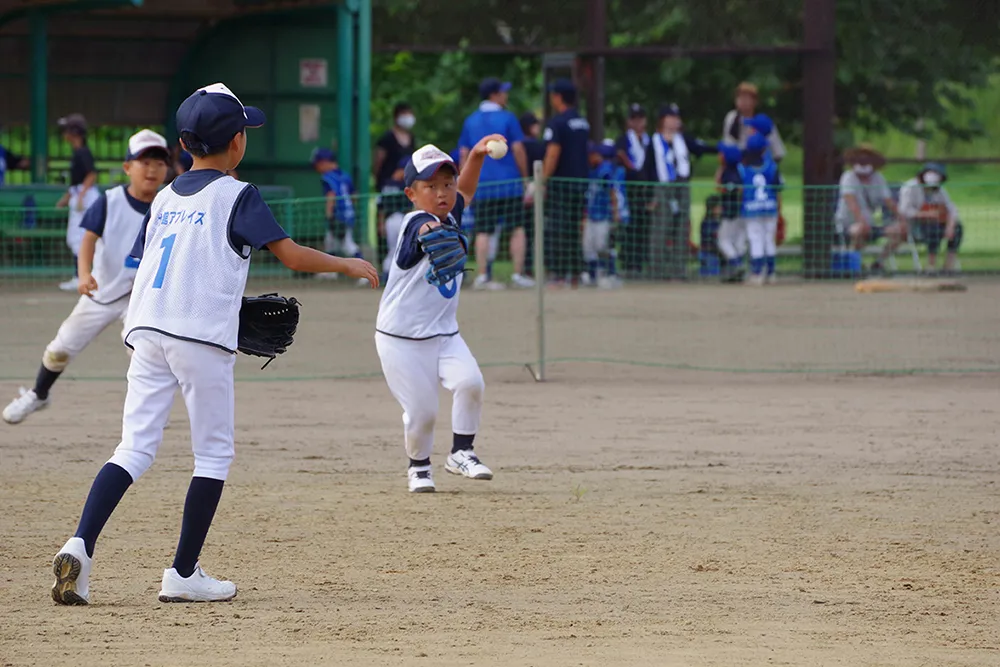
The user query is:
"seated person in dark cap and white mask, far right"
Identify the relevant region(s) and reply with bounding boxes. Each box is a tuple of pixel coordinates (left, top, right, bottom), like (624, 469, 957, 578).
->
(899, 162, 962, 273)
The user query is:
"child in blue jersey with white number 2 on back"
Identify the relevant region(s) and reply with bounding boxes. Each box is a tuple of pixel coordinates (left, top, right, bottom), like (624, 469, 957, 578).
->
(738, 133, 784, 285)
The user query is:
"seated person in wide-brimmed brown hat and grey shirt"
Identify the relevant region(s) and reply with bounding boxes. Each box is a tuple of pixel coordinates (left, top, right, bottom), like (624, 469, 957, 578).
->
(834, 144, 907, 273)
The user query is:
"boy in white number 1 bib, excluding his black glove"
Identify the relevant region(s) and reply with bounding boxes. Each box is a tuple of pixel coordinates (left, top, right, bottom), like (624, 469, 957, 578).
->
(52, 83, 378, 605)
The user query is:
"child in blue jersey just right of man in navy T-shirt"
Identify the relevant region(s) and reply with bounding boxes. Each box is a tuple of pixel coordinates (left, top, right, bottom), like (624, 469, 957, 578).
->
(580, 143, 621, 289)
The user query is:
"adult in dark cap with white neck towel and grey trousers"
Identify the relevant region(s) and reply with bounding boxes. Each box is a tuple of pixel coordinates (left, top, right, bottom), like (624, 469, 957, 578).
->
(644, 104, 718, 278)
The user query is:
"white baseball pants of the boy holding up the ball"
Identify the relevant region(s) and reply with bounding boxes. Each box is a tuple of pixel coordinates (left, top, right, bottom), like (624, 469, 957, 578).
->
(375, 333, 485, 461)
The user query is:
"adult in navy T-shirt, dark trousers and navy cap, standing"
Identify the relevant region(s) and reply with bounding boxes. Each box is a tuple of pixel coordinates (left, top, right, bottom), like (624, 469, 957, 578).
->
(544, 79, 590, 284)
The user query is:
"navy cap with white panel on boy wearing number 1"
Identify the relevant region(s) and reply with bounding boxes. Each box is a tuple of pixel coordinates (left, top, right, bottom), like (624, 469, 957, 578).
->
(177, 83, 267, 152)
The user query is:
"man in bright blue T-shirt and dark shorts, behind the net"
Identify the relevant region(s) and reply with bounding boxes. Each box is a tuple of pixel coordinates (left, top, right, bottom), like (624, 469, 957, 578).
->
(458, 77, 535, 289)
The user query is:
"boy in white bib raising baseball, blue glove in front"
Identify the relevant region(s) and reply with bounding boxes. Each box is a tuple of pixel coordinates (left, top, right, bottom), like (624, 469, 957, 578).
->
(375, 134, 506, 493)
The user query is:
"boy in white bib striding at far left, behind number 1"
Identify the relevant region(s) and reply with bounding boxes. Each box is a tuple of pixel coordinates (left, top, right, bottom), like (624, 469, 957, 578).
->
(3, 130, 169, 424)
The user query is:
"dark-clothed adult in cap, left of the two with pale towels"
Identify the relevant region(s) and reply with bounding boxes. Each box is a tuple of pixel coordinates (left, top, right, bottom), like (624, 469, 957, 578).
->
(615, 104, 652, 273)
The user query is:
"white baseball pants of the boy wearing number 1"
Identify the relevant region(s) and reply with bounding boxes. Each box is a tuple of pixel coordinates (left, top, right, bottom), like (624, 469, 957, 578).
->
(109, 331, 236, 481)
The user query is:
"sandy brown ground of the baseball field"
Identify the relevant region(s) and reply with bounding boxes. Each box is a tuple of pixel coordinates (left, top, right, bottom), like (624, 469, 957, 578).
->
(0, 285, 1000, 667)
